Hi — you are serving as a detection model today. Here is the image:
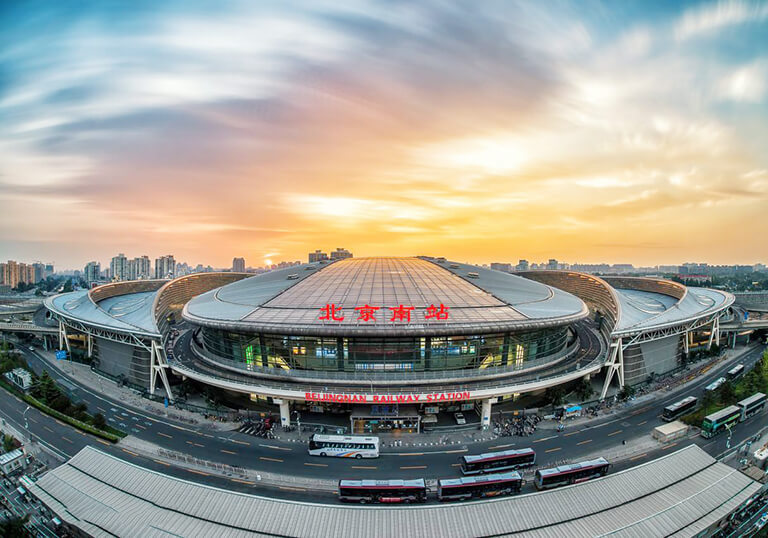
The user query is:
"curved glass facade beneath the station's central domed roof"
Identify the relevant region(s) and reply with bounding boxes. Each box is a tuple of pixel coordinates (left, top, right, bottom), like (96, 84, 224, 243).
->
(202, 327, 571, 373)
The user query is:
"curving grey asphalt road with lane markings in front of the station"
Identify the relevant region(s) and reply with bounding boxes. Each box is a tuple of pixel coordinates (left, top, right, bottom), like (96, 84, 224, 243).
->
(0, 340, 765, 499)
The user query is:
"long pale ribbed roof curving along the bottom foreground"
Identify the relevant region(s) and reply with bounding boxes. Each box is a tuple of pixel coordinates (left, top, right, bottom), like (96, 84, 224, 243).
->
(30, 445, 760, 538)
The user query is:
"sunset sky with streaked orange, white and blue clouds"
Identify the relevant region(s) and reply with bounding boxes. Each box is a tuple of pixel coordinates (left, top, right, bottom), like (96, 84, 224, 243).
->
(0, 0, 768, 268)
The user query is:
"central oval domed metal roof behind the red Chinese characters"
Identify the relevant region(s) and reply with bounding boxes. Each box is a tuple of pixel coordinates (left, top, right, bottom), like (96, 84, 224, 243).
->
(183, 258, 588, 336)
